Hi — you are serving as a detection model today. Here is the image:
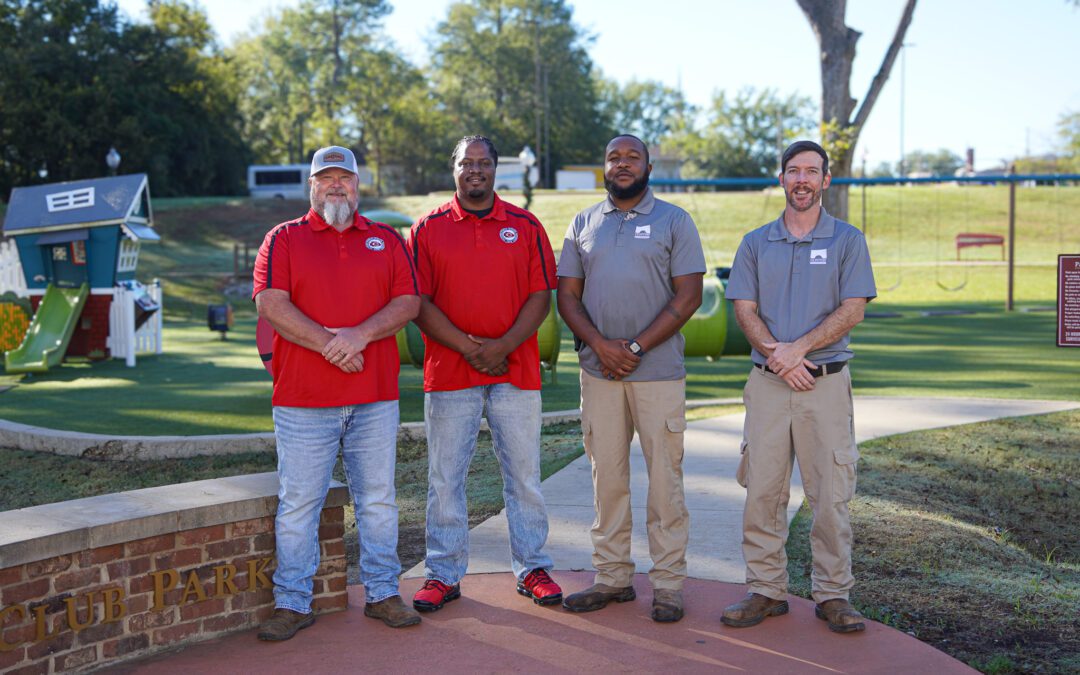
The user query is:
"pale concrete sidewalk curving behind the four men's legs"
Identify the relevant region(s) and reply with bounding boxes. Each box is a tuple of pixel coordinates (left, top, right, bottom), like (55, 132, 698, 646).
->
(406, 396, 1080, 583)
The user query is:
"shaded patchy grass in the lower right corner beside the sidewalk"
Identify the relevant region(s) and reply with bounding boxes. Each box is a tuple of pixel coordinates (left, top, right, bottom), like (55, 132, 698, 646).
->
(787, 410, 1080, 673)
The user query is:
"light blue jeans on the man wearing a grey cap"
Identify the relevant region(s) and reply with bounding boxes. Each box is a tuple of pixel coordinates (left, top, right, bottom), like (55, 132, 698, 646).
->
(273, 401, 401, 613)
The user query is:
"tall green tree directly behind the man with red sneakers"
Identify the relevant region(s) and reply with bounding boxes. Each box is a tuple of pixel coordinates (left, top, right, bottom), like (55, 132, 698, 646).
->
(432, 0, 611, 185)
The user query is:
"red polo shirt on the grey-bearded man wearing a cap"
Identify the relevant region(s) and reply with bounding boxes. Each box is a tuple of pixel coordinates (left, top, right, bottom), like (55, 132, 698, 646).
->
(252, 211, 419, 407)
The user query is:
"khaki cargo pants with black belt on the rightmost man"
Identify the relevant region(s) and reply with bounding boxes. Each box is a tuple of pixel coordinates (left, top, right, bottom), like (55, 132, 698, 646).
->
(739, 368, 859, 603)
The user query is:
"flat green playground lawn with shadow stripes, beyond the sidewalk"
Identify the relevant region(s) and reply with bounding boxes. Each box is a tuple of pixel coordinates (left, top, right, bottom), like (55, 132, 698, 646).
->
(0, 305, 1080, 435)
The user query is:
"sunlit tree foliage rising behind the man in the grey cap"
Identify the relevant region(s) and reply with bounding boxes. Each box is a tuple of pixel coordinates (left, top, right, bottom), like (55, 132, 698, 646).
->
(233, 0, 450, 191)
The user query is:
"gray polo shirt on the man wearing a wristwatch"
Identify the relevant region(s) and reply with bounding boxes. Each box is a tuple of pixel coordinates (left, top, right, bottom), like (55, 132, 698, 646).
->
(558, 188, 705, 381)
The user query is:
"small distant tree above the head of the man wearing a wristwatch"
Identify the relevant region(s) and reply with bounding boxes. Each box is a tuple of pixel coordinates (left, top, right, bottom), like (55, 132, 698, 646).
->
(596, 77, 693, 146)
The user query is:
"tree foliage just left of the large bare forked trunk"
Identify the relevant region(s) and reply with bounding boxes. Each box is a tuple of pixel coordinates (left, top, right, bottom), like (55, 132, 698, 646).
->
(665, 87, 815, 178)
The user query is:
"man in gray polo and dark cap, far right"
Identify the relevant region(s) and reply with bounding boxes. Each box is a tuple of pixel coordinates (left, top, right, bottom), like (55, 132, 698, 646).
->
(721, 140, 877, 633)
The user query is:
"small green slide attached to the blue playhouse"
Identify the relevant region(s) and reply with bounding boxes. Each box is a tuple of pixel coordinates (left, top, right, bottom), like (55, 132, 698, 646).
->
(4, 284, 90, 373)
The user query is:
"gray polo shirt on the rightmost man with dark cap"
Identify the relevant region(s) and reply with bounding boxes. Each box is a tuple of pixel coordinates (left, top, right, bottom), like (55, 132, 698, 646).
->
(727, 208, 877, 365)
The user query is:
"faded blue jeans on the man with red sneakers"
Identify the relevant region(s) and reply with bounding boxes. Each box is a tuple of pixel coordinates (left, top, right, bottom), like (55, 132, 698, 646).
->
(423, 383, 552, 585)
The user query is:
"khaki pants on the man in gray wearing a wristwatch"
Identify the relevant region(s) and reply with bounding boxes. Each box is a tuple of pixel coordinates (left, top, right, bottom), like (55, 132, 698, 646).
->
(581, 370, 690, 591)
